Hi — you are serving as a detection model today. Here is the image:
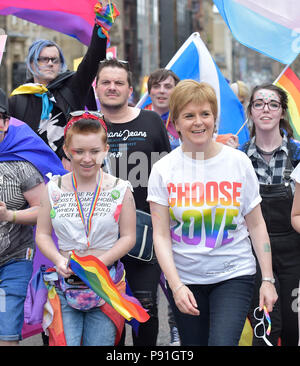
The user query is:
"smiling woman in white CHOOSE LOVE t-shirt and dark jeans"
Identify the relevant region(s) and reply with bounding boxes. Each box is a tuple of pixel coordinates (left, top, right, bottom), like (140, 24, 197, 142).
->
(147, 80, 277, 346)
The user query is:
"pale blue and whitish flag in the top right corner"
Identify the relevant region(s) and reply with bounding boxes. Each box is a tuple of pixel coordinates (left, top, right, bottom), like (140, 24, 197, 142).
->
(213, 0, 300, 64)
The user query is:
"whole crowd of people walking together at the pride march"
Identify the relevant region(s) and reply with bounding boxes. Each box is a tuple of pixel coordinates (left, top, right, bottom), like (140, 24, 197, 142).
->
(0, 1, 300, 346)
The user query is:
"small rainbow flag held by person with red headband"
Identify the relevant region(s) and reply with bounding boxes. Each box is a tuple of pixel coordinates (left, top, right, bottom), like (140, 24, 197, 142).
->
(70, 252, 149, 323)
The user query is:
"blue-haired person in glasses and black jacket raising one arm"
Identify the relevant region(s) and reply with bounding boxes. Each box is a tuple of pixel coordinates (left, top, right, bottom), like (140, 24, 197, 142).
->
(9, 0, 119, 169)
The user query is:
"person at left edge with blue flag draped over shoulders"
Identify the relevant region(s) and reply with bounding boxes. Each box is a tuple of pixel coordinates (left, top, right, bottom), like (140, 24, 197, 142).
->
(0, 89, 65, 346)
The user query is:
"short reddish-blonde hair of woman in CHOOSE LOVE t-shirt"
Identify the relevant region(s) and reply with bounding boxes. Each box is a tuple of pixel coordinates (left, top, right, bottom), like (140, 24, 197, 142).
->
(169, 79, 218, 125)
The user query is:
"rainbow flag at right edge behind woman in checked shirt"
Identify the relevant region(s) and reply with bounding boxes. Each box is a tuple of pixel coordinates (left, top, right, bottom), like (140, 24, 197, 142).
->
(274, 66, 300, 140)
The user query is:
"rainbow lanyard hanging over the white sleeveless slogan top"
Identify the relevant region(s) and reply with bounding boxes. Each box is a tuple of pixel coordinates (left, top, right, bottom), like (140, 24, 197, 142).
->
(72, 169, 103, 247)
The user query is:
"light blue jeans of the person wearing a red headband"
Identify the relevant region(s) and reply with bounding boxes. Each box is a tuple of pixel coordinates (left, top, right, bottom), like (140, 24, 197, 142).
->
(56, 288, 116, 346)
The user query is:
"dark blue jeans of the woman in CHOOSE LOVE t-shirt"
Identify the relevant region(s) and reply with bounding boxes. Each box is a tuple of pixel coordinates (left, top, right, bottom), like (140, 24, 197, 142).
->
(168, 275, 255, 346)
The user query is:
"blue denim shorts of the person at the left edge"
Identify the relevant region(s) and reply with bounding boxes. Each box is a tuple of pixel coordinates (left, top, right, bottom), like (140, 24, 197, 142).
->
(0, 259, 33, 341)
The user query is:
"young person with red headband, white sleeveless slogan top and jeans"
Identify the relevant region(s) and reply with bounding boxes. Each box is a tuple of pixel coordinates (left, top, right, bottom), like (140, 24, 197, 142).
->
(36, 111, 136, 346)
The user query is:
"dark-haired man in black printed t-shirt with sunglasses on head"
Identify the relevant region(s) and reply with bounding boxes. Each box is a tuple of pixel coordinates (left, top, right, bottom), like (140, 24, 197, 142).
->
(96, 59, 171, 346)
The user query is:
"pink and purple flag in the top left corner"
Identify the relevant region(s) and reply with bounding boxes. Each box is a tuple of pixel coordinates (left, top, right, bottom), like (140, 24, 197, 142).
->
(0, 0, 97, 45)
